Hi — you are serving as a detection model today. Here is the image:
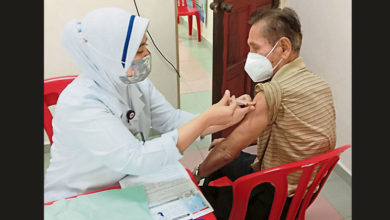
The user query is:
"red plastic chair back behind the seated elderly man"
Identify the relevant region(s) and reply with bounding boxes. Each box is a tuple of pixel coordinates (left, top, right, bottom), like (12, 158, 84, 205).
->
(229, 145, 351, 220)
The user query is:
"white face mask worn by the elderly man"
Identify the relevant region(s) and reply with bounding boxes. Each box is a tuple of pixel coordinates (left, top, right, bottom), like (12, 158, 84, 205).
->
(244, 40, 283, 82)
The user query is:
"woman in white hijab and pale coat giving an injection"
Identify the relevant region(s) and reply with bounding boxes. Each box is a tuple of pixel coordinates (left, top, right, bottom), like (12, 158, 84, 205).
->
(44, 8, 254, 202)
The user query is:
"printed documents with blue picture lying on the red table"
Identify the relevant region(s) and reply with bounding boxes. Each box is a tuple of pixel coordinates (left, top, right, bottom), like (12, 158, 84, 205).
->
(119, 162, 213, 220)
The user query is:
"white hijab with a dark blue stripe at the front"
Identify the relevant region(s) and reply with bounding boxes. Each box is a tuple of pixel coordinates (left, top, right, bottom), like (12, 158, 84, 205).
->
(62, 8, 149, 104)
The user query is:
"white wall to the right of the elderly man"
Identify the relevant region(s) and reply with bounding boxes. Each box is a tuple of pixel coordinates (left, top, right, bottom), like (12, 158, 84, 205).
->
(281, 0, 352, 174)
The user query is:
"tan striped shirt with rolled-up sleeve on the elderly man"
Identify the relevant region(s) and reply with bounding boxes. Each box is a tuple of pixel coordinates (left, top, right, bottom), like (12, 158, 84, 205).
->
(252, 57, 336, 196)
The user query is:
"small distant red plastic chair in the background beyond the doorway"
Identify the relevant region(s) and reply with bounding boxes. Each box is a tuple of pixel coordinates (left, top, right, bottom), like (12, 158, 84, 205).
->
(177, 0, 201, 42)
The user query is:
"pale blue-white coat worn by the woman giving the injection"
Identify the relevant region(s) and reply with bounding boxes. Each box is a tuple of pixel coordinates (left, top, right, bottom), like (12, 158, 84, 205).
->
(44, 75, 195, 202)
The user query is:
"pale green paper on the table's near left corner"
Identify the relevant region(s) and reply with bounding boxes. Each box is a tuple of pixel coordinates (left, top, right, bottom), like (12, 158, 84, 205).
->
(44, 185, 152, 220)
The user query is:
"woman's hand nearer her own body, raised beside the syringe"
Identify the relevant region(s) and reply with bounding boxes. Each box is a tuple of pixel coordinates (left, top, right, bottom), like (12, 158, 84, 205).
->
(204, 90, 238, 126)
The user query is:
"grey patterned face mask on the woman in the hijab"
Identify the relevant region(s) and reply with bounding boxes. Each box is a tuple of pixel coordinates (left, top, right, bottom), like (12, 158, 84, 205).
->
(120, 54, 152, 84)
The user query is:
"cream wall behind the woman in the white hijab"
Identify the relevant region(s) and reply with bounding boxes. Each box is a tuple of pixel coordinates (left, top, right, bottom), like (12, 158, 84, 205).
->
(44, 0, 179, 143)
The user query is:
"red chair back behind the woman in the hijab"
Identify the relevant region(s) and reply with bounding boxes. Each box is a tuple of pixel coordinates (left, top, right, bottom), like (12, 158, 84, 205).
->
(43, 75, 77, 145)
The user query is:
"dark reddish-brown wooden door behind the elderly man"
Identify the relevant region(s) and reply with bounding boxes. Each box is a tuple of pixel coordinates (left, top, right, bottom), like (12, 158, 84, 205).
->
(210, 0, 279, 139)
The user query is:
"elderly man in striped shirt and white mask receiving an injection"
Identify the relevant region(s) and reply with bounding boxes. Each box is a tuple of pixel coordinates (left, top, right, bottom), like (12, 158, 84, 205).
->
(193, 8, 336, 219)
